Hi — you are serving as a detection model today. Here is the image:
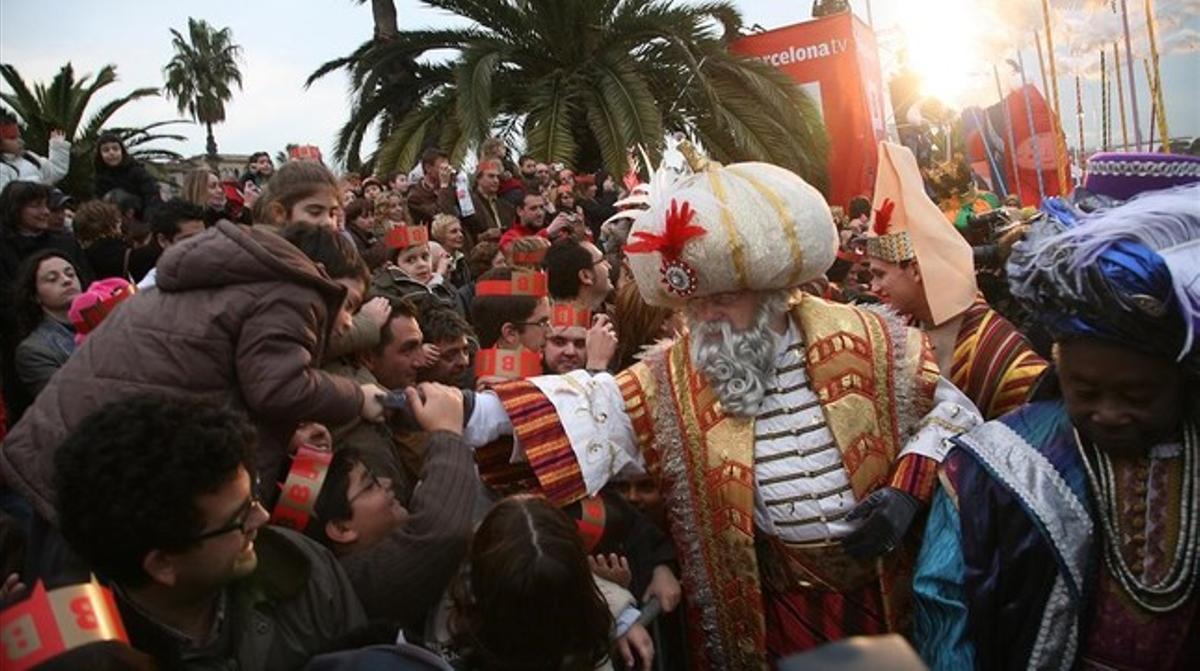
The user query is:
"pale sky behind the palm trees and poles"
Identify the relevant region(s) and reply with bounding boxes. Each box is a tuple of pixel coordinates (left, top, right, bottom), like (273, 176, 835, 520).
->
(0, 0, 1200, 168)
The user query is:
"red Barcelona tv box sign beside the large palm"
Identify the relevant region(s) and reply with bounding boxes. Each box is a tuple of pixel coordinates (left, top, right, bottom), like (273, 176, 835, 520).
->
(733, 12, 887, 206)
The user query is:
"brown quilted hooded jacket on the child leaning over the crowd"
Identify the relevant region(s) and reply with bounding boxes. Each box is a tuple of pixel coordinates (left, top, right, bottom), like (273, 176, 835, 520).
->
(0, 222, 362, 522)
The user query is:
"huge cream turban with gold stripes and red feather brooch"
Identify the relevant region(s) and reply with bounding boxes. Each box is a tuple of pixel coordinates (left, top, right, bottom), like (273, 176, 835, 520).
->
(625, 145, 838, 307)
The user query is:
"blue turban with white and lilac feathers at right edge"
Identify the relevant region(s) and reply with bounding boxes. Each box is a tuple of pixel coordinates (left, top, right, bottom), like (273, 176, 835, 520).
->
(1008, 185, 1200, 372)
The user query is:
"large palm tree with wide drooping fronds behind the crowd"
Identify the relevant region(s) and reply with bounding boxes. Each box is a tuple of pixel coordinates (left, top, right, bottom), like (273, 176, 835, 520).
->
(308, 0, 828, 188)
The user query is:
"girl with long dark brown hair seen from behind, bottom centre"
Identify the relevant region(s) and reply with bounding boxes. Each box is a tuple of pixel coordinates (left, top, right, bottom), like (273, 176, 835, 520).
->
(436, 496, 653, 671)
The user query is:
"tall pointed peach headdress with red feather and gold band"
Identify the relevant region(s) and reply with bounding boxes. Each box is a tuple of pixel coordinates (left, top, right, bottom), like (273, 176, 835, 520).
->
(866, 142, 978, 326)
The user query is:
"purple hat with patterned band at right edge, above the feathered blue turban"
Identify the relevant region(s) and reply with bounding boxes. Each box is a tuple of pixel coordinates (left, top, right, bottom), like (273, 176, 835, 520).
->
(1084, 152, 1200, 200)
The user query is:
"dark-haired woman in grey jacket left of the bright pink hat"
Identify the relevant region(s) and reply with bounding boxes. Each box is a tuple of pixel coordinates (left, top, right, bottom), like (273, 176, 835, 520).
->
(13, 250, 80, 401)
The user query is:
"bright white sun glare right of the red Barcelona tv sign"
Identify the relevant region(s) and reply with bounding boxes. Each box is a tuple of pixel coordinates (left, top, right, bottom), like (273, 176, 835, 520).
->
(899, 0, 982, 108)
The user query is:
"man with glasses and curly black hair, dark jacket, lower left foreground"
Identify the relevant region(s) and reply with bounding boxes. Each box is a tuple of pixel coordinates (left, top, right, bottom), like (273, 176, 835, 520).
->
(55, 396, 366, 670)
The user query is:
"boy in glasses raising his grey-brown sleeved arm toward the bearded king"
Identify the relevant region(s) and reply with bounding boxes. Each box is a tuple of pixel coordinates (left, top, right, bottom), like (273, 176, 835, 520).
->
(306, 383, 479, 628)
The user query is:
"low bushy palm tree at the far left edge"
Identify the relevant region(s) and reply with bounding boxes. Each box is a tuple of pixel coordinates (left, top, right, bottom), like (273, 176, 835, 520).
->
(0, 62, 184, 197)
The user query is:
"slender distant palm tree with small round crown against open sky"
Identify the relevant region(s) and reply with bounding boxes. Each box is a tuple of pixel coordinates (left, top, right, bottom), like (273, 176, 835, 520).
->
(163, 17, 241, 160)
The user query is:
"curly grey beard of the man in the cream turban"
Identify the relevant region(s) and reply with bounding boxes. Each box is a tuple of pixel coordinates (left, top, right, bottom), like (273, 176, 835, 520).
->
(688, 294, 787, 417)
